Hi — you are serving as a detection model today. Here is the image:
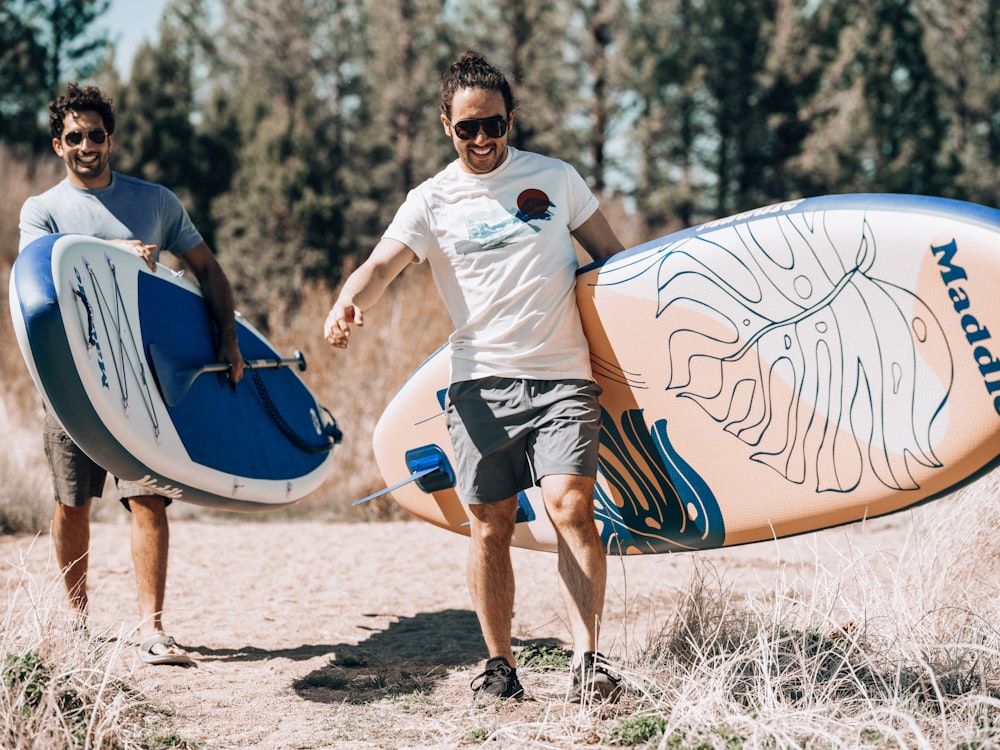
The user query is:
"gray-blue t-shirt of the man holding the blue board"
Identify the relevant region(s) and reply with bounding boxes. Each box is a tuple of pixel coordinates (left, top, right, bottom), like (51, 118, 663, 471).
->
(18, 172, 202, 256)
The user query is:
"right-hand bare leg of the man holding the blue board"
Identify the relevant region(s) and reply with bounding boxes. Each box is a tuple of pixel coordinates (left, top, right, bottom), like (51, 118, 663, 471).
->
(129, 495, 183, 653)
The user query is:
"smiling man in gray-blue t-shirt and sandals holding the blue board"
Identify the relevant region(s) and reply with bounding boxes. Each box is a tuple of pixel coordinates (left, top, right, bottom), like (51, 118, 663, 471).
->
(19, 84, 243, 664)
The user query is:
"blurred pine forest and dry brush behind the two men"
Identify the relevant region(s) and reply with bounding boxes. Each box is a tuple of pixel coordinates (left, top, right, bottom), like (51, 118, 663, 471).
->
(0, 0, 1000, 527)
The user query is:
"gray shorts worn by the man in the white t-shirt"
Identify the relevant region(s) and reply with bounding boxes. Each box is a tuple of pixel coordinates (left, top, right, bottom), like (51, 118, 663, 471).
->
(446, 377, 601, 504)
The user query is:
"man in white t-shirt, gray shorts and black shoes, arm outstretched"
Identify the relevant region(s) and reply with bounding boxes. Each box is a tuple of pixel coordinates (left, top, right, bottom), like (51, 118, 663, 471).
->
(324, 52, 622, 701)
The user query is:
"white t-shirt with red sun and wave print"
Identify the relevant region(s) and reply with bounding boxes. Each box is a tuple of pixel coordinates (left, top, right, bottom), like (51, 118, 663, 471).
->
(384, 148, 598, 382)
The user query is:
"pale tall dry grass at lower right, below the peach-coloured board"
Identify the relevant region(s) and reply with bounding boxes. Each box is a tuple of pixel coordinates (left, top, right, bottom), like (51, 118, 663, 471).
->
(384, 478, 1000, 750)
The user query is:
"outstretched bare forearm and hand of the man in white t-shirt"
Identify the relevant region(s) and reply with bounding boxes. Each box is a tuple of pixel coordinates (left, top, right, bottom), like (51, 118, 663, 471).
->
(323, 237, 417, 349)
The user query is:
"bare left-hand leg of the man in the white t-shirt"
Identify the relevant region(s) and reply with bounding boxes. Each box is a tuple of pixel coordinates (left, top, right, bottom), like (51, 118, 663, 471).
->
(466, 497, 517, 667)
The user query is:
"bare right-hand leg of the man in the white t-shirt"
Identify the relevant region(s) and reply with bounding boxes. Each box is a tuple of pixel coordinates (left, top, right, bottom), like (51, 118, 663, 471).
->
(541, 475, 608, 659)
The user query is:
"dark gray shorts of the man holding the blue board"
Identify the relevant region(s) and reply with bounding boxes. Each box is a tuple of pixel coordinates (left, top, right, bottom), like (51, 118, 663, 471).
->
(43, 410, 172, 509)
